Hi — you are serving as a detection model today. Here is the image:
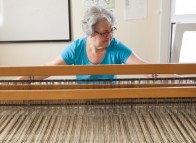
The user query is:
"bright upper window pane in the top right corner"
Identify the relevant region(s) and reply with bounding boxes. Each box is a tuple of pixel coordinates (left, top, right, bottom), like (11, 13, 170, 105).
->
(175, 0, 196, 15)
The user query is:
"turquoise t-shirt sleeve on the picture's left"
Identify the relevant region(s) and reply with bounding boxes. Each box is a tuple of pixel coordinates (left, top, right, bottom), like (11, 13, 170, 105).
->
(61, 42, 76, 65)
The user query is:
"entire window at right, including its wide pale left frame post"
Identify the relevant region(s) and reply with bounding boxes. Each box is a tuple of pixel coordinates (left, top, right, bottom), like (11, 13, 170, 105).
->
(160, 0, 196, 63)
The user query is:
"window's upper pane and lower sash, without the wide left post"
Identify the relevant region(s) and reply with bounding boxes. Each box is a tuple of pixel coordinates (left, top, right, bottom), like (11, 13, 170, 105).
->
(170, 0, 196, 63)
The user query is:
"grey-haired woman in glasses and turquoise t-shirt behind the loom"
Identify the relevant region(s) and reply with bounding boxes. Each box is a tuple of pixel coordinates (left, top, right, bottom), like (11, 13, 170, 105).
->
(18, 6, 149, 80)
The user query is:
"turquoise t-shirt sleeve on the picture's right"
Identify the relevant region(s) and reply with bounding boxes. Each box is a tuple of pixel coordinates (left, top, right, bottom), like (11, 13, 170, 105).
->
(115, 41, 132, 63)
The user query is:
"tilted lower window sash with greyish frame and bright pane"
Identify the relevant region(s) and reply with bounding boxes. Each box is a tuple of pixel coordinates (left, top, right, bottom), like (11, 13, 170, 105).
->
(171, 23, 196, 63)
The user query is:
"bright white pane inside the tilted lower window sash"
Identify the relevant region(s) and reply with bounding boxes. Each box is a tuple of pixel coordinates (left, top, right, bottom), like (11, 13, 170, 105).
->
(179, 31, 196, 63)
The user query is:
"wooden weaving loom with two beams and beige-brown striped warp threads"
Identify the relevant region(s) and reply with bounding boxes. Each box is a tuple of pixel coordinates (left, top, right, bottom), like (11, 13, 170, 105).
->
(0, 64, 196, 143)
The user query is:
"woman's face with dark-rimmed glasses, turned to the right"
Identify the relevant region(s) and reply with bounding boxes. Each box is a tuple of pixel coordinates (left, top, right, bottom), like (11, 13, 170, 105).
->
(93, 21, 114, 48)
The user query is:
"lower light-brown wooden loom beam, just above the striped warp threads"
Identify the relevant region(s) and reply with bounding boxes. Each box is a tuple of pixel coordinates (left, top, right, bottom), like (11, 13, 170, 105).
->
(0, 87, 196, 100)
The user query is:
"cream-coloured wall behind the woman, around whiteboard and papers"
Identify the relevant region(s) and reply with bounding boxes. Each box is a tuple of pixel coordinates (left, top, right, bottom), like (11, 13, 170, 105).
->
(0, 0, 160, 66)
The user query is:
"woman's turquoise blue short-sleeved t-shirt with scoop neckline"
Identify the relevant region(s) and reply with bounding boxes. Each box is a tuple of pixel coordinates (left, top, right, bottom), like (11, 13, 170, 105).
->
(61, 37, 132, 80)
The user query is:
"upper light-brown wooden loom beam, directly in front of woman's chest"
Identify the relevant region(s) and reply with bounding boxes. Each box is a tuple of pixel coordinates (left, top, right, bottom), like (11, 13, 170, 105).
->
(0, 64, 196, 76)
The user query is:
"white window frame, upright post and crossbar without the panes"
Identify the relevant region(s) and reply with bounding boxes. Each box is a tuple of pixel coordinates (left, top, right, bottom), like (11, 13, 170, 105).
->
(160, 0, 196, 63)
